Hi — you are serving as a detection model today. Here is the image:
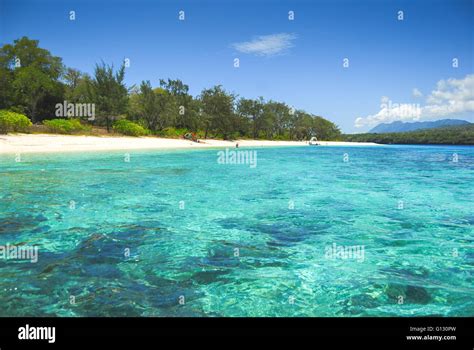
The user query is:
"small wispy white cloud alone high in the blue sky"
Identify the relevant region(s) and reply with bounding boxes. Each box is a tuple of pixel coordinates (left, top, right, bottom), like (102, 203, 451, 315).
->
(232, 33, 296, 56)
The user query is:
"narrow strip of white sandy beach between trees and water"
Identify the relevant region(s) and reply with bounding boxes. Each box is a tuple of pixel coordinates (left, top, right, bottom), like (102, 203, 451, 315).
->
(0, 134, 377, 154)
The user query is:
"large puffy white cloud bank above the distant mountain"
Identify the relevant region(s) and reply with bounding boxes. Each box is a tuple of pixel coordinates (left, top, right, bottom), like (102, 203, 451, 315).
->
(354, 74, 474, 128)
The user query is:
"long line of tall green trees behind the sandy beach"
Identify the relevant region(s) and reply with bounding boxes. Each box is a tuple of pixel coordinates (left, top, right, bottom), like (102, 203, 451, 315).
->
(0, 37, 341, 140)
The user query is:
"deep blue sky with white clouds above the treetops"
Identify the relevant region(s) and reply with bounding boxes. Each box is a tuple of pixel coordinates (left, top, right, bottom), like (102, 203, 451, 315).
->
(0, 0, 474, 133)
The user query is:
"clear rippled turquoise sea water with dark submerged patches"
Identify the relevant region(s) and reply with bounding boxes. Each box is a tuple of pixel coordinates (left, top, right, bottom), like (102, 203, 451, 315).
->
(0, 146, 474, 316)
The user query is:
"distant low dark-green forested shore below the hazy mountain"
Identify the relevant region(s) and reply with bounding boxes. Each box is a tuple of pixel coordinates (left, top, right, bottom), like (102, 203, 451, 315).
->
(343, 124, 474, 145)
